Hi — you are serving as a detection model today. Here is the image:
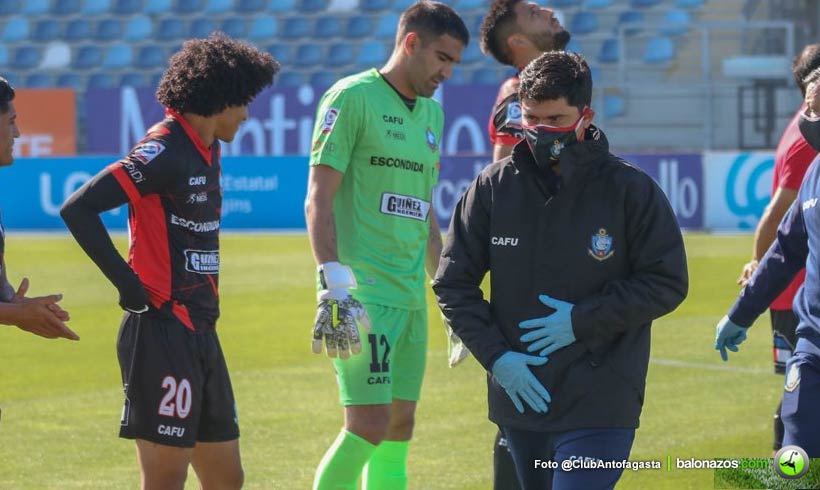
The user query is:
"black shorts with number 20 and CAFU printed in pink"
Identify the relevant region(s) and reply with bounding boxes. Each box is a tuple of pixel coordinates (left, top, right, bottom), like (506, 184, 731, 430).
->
(117, 310, 239, 447)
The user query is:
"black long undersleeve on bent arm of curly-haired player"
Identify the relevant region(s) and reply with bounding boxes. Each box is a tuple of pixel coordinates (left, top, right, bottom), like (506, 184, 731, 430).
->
(60, 164, 148, 310)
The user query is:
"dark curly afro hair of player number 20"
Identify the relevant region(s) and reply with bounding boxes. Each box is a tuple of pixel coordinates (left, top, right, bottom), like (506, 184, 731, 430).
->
(157, 32, 279, 117)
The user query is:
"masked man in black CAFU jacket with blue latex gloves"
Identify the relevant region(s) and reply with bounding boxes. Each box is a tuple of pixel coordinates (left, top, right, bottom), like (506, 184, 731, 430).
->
(433, 52, 688, 490)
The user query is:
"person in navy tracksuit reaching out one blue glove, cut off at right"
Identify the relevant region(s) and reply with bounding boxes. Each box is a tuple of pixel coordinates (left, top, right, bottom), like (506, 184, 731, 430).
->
(715, 68, 820, 458)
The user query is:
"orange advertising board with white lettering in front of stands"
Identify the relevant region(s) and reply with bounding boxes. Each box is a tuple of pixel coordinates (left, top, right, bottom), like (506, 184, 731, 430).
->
(14, 89, 77, 157)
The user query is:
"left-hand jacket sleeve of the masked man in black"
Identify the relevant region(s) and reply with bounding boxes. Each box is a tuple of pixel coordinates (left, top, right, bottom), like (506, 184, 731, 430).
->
(433, 175, 510, 371)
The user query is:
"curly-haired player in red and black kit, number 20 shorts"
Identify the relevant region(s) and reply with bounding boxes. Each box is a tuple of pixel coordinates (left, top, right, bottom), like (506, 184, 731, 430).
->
(61, 33, 279, 490)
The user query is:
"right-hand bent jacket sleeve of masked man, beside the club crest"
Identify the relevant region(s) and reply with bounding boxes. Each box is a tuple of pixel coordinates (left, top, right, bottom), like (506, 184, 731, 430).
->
(572, 172, 689, 350)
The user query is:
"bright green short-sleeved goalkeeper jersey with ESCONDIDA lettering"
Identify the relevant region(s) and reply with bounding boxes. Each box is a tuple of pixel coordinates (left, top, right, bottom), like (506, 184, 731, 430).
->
(310, 69, 444, 309)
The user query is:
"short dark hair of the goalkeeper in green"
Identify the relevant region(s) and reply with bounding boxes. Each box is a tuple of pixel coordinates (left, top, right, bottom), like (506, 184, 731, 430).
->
(396, 0, 470, 46)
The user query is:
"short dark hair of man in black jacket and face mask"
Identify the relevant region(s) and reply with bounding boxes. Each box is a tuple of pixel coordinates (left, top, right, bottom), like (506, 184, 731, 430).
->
(518, 51, 592, 110)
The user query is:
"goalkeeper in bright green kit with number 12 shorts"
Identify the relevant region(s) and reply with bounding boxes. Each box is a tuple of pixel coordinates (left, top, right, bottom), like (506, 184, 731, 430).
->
(305, 2, 469, 490)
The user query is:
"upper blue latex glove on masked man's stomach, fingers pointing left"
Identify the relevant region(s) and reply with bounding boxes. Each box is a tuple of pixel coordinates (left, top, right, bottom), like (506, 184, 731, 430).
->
(518, 294, 575, 356)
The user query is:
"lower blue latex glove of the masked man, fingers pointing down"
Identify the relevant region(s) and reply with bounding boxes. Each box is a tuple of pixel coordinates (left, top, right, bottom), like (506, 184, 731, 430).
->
(493, 351, 552, 413)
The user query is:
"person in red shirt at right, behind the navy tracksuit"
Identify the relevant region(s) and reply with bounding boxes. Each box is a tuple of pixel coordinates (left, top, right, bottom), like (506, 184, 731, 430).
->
(737, 44, 820, 452)
